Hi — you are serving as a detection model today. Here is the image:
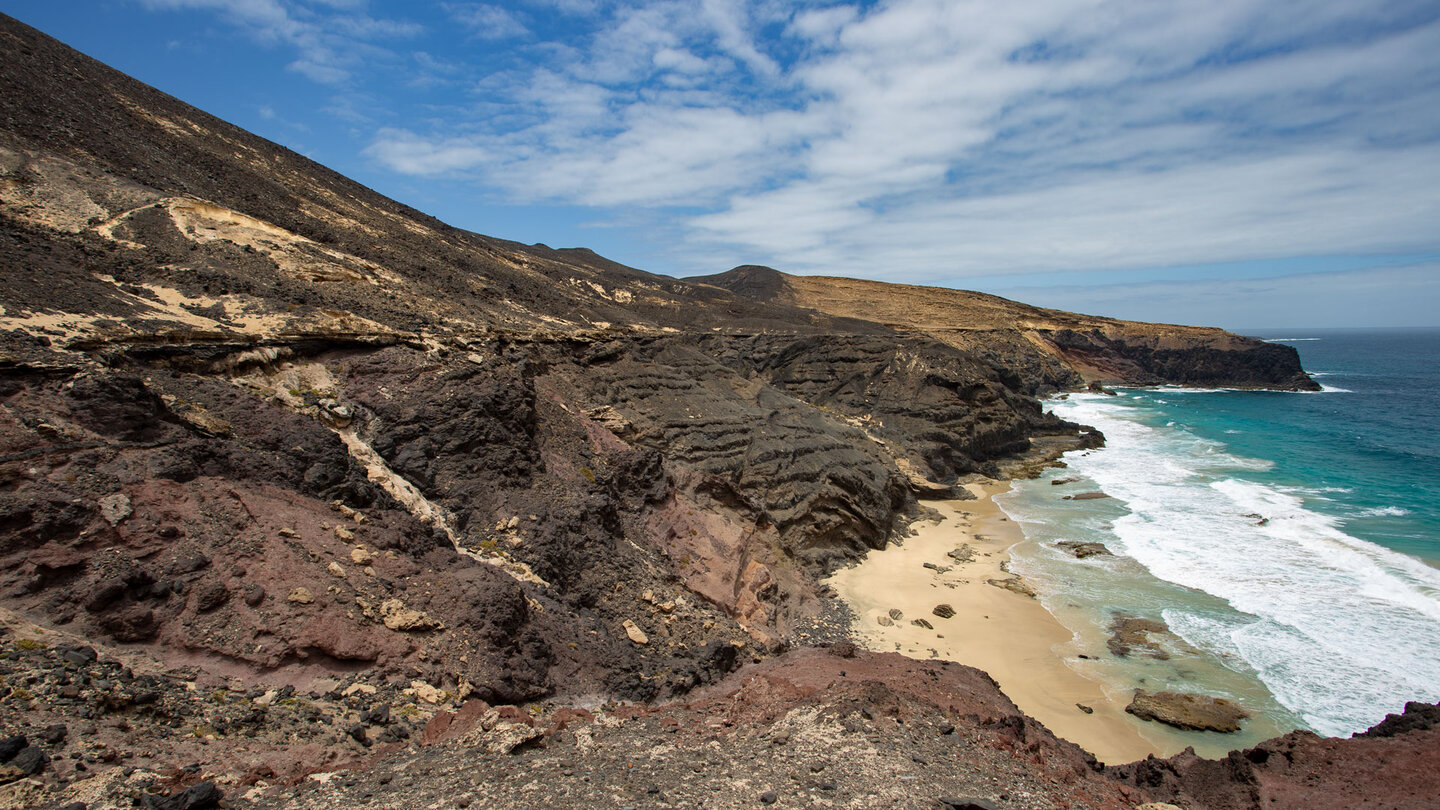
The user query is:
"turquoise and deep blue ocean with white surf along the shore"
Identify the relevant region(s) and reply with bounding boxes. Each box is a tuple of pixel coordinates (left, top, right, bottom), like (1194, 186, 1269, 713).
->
(998, 330, 1440, 754)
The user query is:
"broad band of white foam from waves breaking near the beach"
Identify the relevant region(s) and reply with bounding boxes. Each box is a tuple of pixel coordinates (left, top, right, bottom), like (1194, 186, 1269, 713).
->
(1054, 395, 1440, 735)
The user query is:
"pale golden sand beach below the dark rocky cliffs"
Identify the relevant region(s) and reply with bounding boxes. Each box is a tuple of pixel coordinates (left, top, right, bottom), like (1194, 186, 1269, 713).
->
(828, 481, 1178, 764)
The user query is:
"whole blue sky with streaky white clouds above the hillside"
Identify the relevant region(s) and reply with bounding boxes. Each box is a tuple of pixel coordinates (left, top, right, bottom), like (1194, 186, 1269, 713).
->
(0, 0, 1440, 329)
